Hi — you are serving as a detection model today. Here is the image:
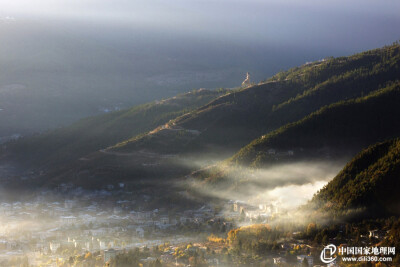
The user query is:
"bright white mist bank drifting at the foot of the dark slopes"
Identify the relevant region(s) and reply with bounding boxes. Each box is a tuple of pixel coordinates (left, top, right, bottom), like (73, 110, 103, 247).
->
(186, 161, 344, 209)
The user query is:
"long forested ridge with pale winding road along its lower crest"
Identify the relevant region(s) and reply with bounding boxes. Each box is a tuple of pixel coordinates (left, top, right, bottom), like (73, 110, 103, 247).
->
(114, 44, 400, 157)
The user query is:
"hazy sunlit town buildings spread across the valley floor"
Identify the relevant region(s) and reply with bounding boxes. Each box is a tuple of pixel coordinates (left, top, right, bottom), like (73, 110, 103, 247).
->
(0, 181, 288, 266)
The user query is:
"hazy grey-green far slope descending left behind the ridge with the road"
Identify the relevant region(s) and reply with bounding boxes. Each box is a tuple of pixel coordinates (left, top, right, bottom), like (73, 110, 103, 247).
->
(2, 90, 227, 168)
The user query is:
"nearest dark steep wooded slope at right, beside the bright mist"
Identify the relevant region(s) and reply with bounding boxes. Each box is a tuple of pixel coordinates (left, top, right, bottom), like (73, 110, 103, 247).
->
(309, 139, 400, 219)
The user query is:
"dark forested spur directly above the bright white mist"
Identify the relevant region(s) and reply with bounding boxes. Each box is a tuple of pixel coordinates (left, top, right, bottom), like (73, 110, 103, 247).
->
(231, 82, 400, 166)
